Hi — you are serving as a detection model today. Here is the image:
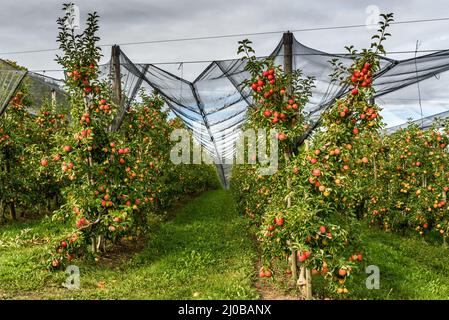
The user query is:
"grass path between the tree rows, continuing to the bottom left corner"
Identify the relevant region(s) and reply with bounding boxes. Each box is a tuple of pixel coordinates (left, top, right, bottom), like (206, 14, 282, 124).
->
(0, 190, 258, 299)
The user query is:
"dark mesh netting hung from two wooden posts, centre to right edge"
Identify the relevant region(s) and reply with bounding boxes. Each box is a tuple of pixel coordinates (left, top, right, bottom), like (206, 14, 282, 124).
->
(100, 33, 449, 185)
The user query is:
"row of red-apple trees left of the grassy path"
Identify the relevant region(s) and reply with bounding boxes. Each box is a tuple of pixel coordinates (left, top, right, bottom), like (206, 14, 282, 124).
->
(0, 8, 218, 268)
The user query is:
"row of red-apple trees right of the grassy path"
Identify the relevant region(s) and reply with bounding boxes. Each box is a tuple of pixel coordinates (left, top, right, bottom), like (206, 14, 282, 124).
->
(231, 14, 449, 298)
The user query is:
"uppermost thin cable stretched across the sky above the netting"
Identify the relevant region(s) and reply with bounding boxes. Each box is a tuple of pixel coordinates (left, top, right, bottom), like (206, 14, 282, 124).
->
(0, 17, 449, 55)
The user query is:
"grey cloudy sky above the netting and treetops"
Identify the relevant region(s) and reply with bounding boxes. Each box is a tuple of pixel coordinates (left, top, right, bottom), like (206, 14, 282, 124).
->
(0, 0, 449, 79)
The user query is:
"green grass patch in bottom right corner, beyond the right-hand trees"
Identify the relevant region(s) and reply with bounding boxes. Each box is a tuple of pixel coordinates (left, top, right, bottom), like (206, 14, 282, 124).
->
(349, 228, 449, 300)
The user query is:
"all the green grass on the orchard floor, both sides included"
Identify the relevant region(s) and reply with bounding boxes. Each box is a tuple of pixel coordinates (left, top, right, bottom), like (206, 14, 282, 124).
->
(0, 190, 449, 299)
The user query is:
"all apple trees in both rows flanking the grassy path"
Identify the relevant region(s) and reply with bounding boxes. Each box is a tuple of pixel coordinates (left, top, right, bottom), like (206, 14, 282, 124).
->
(0, 6, 449, 299)
